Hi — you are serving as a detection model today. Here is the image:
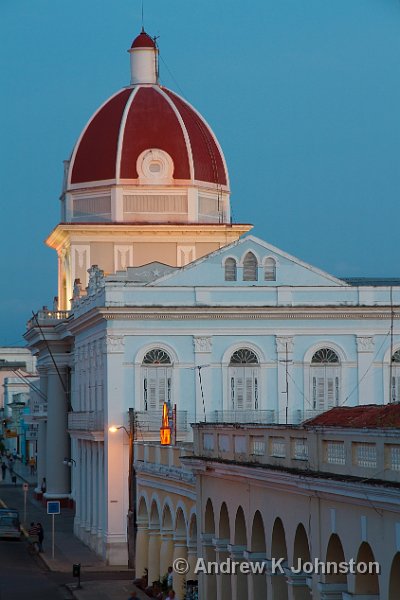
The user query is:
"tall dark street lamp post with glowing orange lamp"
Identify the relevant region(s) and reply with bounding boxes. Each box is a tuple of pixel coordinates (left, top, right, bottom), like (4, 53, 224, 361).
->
(108, 408, 137, 569)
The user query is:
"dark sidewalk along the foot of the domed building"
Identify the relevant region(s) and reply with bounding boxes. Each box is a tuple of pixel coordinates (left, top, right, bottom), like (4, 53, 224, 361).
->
(0, 461, 148, 600)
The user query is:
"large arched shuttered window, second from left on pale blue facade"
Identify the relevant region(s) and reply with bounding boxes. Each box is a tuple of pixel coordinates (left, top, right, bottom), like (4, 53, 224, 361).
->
(229, 348, 260, 410)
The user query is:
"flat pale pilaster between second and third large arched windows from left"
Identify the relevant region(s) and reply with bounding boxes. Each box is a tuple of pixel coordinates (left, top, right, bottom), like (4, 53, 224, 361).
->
(275, 335, 294, 423)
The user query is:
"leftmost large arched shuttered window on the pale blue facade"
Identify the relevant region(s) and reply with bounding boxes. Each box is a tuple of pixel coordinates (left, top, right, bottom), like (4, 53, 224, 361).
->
(142, 348, 172, 410)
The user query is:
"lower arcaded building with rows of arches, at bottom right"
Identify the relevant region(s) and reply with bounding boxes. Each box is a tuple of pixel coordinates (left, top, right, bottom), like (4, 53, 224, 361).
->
(130, 403, 400, 600)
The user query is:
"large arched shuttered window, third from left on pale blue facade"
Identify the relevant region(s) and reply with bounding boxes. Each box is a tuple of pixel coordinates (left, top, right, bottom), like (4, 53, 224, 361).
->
(311, 348, 340, 412)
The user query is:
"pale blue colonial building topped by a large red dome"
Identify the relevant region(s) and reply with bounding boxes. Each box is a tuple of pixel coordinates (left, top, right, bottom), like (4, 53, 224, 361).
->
(25, 27, 400, 564)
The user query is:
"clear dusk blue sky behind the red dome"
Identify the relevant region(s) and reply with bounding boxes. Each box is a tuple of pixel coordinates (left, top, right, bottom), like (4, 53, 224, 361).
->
(0, 0, 400, 345)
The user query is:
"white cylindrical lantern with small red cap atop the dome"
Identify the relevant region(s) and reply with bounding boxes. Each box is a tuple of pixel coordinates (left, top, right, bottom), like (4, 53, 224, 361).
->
(128, 30, 158, 85)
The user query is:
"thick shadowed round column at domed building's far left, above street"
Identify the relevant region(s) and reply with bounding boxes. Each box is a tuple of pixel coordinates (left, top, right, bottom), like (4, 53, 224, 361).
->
(45, 367, 70, 499)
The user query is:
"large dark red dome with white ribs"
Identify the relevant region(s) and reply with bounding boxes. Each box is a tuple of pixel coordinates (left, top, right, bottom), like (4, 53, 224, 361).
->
(70, 85, 228, 186)
